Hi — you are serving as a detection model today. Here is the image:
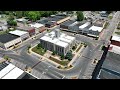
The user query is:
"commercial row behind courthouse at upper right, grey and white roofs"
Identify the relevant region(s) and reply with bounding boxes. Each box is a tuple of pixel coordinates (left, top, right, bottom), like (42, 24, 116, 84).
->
(60, 20, 106, 37)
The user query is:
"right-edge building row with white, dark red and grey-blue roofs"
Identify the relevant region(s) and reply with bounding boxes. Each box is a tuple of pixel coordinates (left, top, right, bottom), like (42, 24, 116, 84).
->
(97, 35, 120, 79)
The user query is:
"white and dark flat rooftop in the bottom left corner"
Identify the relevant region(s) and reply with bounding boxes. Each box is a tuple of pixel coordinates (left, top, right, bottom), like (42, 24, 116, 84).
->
(0, 62, 37, 79)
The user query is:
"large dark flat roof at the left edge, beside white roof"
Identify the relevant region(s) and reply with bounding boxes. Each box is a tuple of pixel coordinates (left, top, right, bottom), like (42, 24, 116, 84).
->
(0, 34, 19, 43)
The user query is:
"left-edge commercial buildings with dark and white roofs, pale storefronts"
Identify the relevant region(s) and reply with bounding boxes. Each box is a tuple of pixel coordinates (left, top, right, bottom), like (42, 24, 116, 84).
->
(0, 30, 30, 50)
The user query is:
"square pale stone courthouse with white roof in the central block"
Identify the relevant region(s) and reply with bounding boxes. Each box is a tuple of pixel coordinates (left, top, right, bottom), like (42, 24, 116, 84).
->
(40, 29, 75, 55)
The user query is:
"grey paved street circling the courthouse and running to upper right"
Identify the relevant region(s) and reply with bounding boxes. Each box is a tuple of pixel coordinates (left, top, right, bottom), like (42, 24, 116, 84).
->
(0, 11, 120, 79)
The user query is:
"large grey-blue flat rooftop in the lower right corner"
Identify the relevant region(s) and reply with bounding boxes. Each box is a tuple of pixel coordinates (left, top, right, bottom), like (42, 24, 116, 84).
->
(99, 51, 120, 79)
